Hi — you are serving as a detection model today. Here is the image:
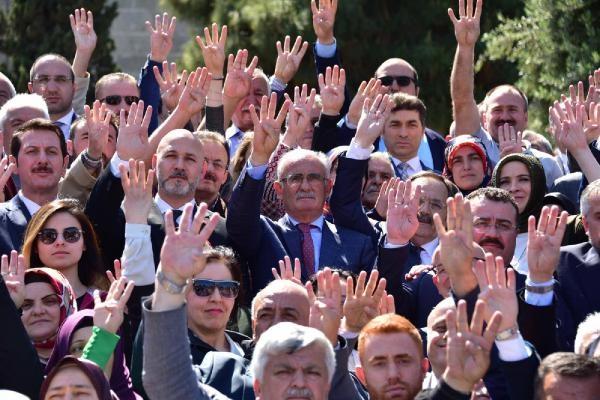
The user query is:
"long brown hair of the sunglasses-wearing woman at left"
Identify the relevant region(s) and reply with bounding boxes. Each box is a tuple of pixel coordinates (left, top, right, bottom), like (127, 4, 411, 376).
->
(21, 199, 108, 290)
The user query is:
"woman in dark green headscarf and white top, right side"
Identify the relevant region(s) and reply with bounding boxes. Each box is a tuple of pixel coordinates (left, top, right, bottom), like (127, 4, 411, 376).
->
(491, 154, 546, 275)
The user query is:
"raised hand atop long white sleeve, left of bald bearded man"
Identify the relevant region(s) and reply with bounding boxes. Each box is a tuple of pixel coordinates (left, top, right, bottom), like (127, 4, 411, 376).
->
(119, 159, 154, 224)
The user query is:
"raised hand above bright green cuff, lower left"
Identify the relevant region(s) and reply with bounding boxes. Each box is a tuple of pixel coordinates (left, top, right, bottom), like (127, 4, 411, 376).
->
(94, 277, 135, 333)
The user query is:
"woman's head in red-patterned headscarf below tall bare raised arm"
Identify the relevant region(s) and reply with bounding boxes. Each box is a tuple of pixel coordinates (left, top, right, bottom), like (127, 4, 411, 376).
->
(443, 135, 492, 196)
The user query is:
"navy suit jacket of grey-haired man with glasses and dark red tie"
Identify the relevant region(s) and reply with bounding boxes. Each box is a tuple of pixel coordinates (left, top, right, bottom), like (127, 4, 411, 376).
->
(227, 171, 375, 294)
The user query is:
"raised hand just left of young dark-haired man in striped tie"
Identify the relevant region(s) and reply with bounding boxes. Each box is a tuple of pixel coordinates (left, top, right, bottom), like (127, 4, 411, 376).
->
(354, 94, 393, 148)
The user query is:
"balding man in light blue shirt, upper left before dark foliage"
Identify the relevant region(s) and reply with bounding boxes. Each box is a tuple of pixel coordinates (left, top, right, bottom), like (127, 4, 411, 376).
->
(27, 54, 77, 139)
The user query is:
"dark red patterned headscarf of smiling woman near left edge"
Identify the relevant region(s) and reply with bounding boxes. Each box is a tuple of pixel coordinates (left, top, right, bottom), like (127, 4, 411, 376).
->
(25, 268, 77, 349)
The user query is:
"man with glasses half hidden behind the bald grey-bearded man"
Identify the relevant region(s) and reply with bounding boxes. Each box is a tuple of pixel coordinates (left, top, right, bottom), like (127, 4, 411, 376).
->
(195, 132, 229, 218)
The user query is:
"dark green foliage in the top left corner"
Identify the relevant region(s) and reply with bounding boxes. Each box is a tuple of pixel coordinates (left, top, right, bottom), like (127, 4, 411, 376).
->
(0, 0, 117, 98)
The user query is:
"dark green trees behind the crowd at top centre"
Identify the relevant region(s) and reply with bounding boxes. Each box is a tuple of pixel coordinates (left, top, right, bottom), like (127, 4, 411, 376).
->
(161, 0, 522, 132)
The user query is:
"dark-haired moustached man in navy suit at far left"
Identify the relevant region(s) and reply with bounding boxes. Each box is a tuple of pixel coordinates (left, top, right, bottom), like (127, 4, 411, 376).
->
(0, 118, 69, 254)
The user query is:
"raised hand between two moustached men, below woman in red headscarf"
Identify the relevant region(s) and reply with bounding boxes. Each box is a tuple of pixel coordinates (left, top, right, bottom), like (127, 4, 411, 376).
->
(433, 193, 473, 278)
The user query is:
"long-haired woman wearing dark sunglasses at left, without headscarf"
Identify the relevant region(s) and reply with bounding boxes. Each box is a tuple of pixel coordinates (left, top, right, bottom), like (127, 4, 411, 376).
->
(22, 199, 108, 310)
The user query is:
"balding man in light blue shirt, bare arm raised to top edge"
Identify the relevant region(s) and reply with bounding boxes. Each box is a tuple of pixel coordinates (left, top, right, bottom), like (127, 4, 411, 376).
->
(450, 0, 563, 189)
